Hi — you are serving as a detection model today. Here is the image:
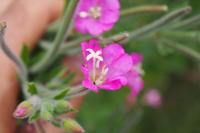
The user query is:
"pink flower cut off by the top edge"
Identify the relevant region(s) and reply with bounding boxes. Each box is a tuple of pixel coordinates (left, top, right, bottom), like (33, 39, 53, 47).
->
(75, 0, 120, 36)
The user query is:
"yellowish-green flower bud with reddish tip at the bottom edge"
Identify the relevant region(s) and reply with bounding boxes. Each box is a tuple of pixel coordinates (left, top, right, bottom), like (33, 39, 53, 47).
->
(63, 119, 85, 133)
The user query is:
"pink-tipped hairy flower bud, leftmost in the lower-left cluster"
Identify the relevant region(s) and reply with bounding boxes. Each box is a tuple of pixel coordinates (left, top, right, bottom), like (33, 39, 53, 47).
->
(13, 101, 33, 119)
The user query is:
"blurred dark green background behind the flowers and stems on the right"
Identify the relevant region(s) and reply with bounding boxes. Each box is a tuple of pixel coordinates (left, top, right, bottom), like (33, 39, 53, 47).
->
(68, 0, 200, 133)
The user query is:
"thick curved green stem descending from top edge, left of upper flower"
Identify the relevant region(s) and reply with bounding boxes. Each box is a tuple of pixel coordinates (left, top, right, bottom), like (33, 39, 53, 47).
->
(30, 0, 78, 73)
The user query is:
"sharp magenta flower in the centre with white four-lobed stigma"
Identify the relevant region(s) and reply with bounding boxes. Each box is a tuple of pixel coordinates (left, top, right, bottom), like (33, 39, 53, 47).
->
(81, 39, 133, 92)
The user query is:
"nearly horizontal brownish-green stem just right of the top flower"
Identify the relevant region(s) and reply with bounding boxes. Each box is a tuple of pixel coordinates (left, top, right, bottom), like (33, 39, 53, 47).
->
(121, 5, 168, 16)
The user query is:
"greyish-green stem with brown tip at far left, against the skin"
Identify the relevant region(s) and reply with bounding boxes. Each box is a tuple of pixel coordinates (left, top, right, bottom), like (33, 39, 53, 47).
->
(0, 23, 27, 82)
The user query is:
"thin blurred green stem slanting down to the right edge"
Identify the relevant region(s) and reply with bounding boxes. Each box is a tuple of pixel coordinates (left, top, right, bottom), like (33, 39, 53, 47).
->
(161, 38, 200, 62)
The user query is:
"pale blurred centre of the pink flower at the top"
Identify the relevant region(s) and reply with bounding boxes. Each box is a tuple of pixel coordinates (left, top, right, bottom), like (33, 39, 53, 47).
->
(79, 6, 102, 19)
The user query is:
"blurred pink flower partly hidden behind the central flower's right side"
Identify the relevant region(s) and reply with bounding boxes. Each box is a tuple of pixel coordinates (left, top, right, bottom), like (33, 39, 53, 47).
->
(126, 53, 144, 98)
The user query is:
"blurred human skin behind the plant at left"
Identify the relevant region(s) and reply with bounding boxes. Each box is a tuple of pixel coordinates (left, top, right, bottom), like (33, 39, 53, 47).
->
(0, 0, 83, 133)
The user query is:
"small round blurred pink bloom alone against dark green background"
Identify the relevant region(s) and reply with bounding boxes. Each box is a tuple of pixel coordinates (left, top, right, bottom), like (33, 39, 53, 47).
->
(144, 89, 162, 108)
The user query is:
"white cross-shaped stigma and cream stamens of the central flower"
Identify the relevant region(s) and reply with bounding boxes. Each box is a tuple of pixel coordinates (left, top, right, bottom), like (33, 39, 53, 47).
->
(86, 49, 108, 85)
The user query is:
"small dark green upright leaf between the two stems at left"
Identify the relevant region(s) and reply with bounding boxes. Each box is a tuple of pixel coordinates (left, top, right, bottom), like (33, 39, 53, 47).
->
(20, 43, 30, 66)
